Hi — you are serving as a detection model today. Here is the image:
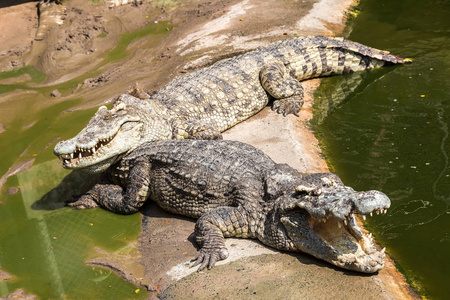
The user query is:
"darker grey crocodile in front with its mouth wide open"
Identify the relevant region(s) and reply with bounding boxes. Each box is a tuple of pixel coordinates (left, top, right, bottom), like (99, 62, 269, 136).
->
(67, 140, 390, 273)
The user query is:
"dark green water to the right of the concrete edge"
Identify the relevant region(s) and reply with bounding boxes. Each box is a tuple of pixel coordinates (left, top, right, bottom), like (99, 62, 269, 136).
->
(315, 0, 450, 299)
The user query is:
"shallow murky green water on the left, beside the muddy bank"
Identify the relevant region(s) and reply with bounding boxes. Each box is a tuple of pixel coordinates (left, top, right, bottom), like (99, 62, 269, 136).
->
(0, 22, 170, 299)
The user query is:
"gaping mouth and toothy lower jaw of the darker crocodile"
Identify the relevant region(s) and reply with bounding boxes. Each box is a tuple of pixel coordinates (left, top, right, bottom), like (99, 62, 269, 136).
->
(281, 207, 387, 273)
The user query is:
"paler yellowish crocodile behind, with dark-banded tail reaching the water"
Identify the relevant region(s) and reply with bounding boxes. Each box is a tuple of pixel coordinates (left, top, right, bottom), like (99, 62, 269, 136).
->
(54, 36, 411, 172)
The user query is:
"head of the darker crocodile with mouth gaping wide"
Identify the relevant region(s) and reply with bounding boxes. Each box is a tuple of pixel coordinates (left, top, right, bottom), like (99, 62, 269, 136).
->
(279, 173, 390, 273)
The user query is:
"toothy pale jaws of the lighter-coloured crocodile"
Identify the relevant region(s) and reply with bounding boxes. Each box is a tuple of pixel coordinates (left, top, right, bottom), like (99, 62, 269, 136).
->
(54, 122, 143, 173)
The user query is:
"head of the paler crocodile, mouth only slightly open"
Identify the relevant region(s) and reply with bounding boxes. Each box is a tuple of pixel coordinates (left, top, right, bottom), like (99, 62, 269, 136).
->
(53, 94, 172, 173)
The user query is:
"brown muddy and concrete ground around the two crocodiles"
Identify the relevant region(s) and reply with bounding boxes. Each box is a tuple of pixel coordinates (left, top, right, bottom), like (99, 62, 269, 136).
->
(0, 0, 416, 299)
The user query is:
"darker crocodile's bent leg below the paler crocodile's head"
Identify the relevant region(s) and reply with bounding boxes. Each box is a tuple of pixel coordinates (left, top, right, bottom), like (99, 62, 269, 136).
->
(67, 159, 150, 214)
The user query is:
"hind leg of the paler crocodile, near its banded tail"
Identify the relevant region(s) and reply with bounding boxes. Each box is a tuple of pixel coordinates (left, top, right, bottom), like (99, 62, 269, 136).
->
(259, 63, 303, 117)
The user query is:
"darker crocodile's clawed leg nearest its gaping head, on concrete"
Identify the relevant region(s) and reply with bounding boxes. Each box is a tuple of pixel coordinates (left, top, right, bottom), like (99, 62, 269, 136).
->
(191, 207, 250, 272)
